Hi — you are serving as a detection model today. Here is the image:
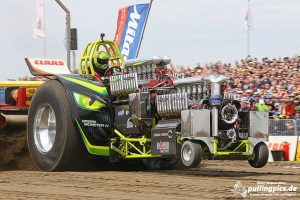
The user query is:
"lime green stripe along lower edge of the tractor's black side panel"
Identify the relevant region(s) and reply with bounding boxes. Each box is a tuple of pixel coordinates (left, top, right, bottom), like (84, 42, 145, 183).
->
(75, 119, 109, 156)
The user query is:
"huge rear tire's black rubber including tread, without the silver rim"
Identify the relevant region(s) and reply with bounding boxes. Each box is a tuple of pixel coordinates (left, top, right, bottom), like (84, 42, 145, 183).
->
(27, 80, 83, 171)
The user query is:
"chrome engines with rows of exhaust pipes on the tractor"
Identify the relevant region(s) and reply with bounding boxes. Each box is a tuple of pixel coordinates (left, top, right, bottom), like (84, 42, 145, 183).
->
(110, 59, 249, 149)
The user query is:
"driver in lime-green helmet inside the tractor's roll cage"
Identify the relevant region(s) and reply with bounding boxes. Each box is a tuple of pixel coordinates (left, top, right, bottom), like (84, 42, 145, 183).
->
(93, 51, 109, 76)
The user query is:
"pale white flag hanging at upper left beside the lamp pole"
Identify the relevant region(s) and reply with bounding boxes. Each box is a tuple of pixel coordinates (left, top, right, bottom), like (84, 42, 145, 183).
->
(33, 0, 45, 38)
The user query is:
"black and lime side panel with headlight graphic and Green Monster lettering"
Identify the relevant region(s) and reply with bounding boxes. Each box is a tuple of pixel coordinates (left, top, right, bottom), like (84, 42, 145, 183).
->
(56, 75, 114, 156)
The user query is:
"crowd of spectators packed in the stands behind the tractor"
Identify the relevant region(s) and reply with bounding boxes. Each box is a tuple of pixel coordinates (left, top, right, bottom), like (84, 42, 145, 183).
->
(172, 56, 300, 119)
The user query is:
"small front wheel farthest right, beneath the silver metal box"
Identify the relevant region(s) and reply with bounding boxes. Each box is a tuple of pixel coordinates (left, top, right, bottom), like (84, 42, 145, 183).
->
(248, 142, 269, 168)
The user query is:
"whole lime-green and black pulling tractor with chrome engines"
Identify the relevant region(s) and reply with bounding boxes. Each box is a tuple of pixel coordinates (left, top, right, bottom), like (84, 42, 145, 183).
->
(22, 39, 268, 171)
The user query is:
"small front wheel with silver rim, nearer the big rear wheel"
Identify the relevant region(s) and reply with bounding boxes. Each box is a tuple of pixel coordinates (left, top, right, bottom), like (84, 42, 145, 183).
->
(181, 140, 202, 168)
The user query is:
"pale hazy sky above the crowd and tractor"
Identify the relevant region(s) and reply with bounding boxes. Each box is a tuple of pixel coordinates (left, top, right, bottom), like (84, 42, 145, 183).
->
(0, 0, 300, 80)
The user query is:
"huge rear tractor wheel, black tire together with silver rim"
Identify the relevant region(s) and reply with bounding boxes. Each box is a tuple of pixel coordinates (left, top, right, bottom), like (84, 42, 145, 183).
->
(27, 80, 84, 171)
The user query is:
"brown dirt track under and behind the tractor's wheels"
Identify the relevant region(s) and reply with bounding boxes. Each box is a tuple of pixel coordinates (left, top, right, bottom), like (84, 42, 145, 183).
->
(0, 130, 300, 200)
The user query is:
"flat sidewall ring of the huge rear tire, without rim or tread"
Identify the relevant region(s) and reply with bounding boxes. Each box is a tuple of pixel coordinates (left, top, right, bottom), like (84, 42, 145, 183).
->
(27, 84, 67, 171)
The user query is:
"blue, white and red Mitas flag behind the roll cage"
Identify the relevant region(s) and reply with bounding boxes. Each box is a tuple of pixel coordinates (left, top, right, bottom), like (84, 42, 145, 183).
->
(114, 3, 150, 61)
